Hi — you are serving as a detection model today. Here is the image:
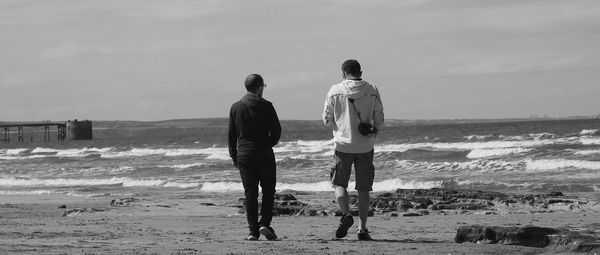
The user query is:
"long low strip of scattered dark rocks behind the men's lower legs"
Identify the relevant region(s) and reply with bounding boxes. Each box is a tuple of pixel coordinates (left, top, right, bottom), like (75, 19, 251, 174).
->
(228, 188, 600, 216)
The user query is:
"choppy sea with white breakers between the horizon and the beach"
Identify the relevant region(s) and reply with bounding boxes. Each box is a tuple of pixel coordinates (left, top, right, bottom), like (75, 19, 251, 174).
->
(0, 119, 600, 197)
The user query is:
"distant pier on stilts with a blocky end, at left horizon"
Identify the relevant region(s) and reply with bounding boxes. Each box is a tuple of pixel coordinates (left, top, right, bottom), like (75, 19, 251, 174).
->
(0, 120, 93, 143)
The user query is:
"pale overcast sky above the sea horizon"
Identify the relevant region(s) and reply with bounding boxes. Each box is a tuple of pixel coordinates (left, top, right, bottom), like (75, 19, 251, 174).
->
(0, 0, 600, 121)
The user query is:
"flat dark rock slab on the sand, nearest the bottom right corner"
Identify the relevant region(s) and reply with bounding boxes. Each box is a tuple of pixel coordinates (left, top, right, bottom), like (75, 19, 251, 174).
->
(454, 224, 600, 252)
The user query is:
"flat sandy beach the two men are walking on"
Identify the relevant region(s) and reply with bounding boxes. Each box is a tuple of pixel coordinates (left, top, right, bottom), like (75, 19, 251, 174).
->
(0, 191, 600, 254)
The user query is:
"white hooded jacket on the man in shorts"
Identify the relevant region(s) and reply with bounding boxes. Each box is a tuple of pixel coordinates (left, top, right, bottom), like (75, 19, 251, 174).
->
(323, 80, 384, 153)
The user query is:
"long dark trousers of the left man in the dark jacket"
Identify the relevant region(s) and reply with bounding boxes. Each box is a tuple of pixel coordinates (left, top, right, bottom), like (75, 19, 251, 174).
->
(237, 150, 276, 233)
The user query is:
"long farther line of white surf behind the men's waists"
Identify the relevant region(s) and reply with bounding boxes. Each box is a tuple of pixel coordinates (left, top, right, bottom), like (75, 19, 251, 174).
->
(0, 130, 600, 161)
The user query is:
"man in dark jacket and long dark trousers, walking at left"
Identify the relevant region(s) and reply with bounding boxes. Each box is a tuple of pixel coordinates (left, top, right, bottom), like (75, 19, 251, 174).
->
(229, 74, 281, 240)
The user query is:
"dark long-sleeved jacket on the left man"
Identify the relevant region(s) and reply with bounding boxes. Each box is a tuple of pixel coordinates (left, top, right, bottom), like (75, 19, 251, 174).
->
(229, 93, 281, 163)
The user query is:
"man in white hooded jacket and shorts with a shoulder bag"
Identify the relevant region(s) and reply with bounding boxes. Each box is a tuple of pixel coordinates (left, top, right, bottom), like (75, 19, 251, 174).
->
(323, 59, 384, 240)
